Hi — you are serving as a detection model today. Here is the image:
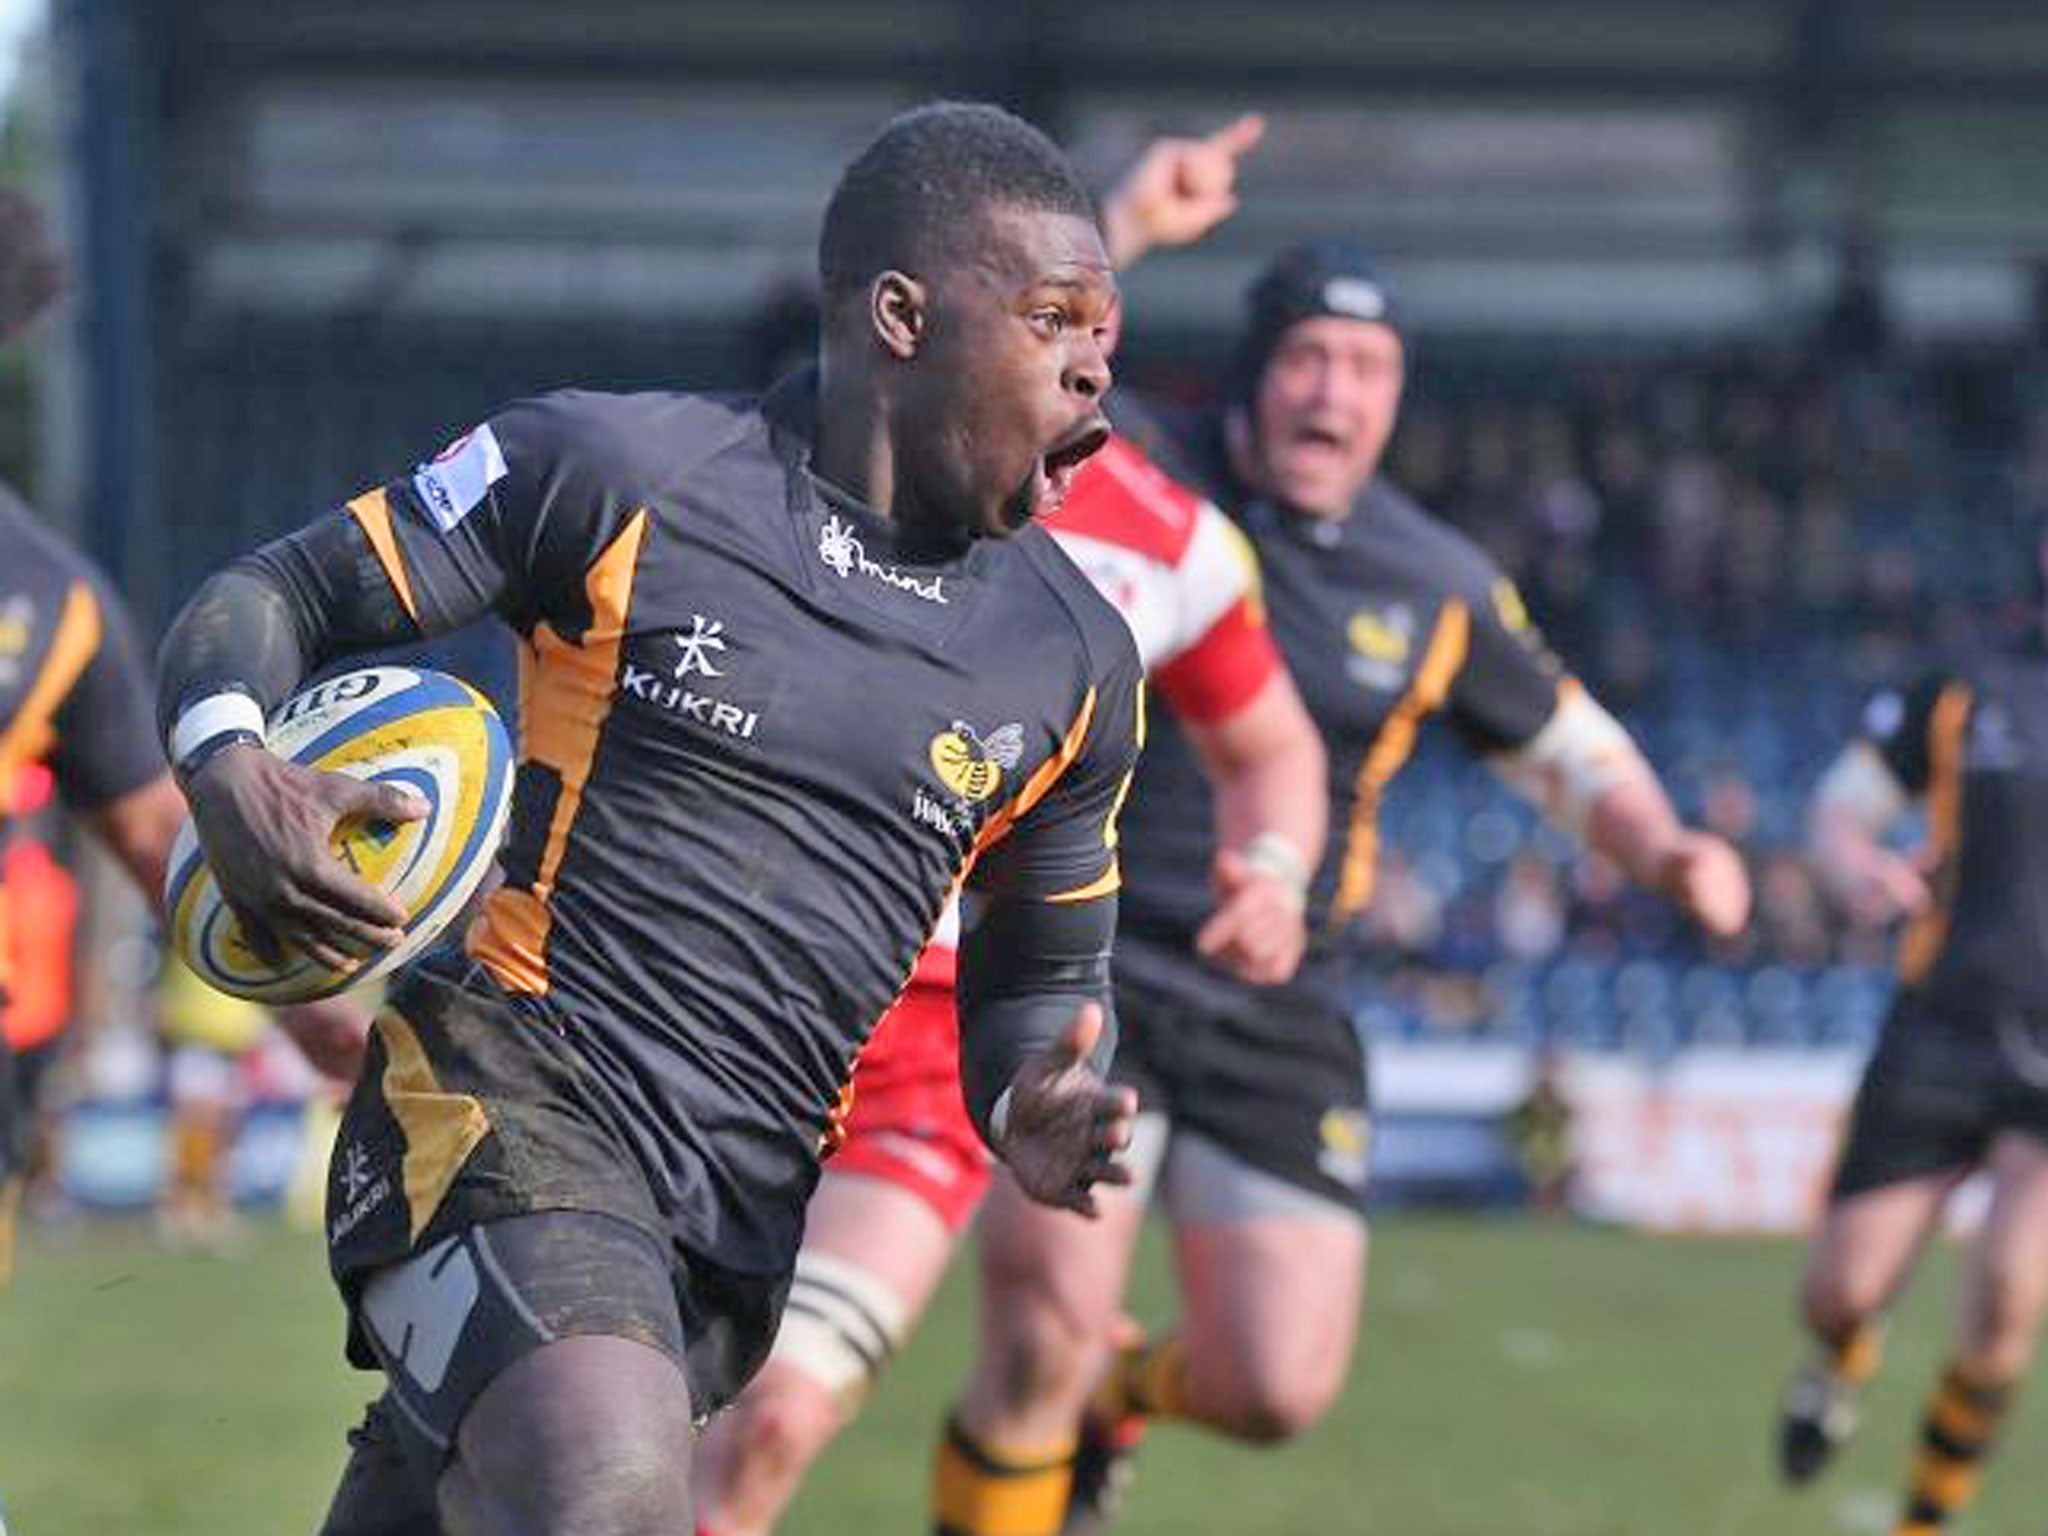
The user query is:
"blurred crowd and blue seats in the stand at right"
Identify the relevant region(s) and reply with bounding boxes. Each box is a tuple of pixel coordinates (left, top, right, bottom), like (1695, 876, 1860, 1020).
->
(1302, 337, 2048, 1053)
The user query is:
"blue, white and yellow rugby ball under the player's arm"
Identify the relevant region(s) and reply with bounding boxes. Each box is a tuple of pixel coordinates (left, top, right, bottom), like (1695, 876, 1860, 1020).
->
(164, 668, 512, 1004)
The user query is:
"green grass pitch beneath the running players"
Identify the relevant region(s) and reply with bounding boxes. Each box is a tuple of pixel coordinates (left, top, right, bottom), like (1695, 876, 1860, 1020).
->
(0, 1217, 2048, 1536)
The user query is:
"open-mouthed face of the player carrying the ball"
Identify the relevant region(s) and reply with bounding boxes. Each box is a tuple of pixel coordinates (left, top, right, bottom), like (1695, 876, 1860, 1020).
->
(901, 209, 1116, 537)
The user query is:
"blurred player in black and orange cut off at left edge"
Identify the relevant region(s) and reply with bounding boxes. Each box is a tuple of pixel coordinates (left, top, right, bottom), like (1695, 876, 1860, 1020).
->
(0, 186, 184, 1276)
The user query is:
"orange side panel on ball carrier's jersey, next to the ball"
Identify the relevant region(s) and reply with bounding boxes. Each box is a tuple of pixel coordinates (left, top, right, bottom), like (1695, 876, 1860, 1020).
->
(469, 508, 647, 995)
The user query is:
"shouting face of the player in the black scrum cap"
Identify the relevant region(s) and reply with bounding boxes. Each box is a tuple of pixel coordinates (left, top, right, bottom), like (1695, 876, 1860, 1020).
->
(1241, 315, 1405, 518)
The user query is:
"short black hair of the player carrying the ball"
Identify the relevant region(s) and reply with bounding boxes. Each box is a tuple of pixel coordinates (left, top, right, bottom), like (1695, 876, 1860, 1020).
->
(817, 100, 1096, 305)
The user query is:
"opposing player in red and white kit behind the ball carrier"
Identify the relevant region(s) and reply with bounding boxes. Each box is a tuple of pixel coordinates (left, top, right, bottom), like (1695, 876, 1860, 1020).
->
(698, 421, 1323, 1536)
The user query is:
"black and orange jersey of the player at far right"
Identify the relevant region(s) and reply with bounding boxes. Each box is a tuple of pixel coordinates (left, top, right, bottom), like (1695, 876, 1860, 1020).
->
(1862, 647, 2048, 1020)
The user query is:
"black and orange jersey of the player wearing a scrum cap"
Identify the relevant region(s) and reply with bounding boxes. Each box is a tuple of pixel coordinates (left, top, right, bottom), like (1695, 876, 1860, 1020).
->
(1120, 455, 1575, 950)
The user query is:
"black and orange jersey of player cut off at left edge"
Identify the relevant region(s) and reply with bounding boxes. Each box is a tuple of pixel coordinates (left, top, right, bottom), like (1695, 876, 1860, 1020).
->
(0, 485, 164, 987)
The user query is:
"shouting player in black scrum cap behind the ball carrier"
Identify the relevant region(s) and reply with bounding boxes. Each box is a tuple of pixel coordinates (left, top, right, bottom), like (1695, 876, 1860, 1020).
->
(936, 135, 1749, 1536)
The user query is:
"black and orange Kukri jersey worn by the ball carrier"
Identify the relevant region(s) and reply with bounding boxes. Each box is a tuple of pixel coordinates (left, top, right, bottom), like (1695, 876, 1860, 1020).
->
(333, 381, 1143, 1270)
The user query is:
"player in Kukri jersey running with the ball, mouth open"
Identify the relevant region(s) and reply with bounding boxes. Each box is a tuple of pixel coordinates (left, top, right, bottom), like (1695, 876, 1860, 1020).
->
(164, 104, 1141, 1534)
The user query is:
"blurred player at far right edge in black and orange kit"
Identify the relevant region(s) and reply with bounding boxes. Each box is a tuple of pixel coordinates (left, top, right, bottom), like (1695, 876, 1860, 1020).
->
(1780, 573, 2048, 1536)
